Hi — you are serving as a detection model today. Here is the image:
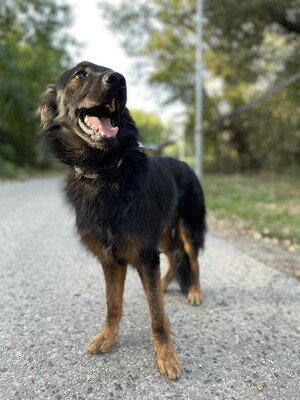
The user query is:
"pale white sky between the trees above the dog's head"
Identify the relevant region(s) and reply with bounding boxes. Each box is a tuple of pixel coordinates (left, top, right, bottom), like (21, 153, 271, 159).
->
(67, 0, 180, 121)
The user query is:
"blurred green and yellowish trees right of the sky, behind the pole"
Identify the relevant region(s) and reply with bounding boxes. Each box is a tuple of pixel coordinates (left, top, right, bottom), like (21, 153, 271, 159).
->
(101, 0, 300, 171)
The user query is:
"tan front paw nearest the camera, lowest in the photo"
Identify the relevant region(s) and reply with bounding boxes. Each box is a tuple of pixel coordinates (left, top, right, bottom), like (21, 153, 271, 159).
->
(156, 346, 182, 381)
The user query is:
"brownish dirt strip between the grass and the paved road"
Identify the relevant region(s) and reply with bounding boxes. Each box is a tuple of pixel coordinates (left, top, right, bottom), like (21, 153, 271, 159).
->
(208, 215, 300, 279)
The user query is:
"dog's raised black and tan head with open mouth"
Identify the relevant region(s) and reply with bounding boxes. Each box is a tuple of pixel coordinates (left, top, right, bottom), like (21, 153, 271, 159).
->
(40, 62, 127, 149)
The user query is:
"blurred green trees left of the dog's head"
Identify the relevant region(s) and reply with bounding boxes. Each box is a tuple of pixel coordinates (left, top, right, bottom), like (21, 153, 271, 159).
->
(0, 0, 73, 174)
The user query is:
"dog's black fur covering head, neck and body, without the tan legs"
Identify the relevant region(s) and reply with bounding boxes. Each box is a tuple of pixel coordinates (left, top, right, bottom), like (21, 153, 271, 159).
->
(40, 62, 206, 292)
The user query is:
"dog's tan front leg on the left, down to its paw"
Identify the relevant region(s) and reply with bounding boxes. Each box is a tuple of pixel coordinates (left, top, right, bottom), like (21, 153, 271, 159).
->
(86, 260, 127, 354)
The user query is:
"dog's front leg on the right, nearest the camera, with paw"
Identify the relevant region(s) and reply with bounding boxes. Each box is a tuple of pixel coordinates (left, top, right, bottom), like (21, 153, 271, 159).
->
(137, 248, 182, 380)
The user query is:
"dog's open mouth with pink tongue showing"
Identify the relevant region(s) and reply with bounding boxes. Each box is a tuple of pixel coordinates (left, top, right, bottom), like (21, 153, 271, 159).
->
(79, 114, 119, 140)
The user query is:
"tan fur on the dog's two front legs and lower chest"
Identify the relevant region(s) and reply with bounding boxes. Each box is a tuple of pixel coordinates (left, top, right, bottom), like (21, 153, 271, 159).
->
(82, 232, 182, 380)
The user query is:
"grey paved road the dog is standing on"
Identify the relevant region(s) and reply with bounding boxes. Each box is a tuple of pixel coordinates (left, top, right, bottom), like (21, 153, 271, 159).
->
(0, 178, 300, 400)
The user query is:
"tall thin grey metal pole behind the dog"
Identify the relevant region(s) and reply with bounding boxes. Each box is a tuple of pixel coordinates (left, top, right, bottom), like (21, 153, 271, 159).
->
(195, 0, 203, 179)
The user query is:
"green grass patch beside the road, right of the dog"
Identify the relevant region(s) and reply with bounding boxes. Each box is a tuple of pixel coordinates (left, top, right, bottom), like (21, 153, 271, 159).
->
(203, 175, 300, 243)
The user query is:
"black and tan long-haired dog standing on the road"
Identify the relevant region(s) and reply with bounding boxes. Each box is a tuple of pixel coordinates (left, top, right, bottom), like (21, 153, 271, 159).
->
(39, 62, 206, 380)
